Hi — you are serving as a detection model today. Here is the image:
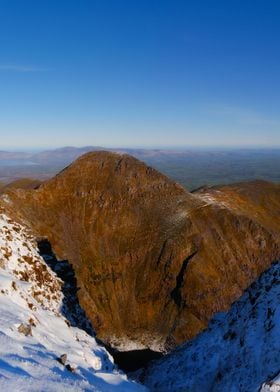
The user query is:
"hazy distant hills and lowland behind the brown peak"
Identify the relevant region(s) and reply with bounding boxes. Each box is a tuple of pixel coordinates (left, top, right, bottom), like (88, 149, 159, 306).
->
(0, 146, 280, 190)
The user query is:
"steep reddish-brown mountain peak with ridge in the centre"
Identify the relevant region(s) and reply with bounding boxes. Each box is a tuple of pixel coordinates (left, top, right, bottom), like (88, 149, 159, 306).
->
(5, 152, 280, 348)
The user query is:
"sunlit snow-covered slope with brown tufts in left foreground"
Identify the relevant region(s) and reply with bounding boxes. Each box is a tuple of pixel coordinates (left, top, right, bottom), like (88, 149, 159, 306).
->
(0, 214, 146, 392)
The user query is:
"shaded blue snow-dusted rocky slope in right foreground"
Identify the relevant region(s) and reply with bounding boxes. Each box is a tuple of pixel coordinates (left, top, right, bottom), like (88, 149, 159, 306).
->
(145, 263, 280, 392)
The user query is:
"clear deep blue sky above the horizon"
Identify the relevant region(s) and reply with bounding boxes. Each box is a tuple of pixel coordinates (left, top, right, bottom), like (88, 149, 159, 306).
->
(0, 0, 280, 149)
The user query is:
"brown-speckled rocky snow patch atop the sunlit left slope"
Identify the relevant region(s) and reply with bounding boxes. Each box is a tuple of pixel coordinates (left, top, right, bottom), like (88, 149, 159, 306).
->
(0, 215, 62, 312)
